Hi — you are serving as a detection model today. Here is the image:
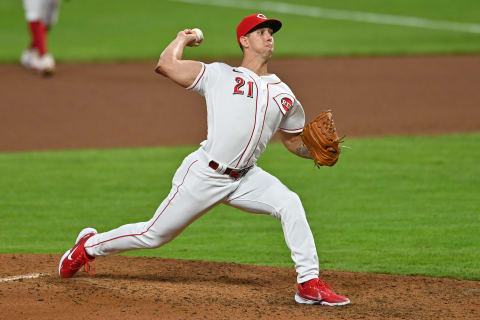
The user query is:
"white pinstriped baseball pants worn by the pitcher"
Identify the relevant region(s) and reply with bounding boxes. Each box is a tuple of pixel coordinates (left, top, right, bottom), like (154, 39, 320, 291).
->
(85, 148, 319, 283)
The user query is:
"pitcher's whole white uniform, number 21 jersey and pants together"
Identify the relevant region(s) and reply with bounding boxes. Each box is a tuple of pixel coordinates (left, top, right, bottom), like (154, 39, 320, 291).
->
(85, 63, 319, 283)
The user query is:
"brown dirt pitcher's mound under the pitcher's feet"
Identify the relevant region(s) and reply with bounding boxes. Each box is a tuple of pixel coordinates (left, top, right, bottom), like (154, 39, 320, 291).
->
(0, 254, 480, 320)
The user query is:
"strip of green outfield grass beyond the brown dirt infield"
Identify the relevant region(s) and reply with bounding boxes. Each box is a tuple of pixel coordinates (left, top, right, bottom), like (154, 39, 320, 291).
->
(0, 0, 480, 63)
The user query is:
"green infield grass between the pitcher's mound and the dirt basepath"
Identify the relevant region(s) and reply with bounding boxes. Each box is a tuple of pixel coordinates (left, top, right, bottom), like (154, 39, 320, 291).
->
(0, 133, 480, 280)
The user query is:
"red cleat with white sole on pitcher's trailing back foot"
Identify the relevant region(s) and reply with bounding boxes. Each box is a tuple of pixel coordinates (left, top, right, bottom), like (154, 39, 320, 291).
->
(58, 228, 97, 278)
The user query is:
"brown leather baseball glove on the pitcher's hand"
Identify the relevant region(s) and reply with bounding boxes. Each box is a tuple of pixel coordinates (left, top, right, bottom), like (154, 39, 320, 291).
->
(300, 110, 343, 167)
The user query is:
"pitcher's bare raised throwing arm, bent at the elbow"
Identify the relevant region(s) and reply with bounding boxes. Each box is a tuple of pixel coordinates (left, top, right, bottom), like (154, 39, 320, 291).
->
(155, 29, 203, 88)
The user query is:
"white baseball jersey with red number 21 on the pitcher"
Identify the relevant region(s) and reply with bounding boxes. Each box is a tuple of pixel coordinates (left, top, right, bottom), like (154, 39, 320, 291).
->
(187, 63, 305, 168)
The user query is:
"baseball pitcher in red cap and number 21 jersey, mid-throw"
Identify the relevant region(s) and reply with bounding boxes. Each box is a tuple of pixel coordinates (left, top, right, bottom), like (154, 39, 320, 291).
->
(59, 14, 350, 306)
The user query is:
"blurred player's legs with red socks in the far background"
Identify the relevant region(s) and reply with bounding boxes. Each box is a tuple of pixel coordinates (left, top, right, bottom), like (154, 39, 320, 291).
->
(20, 0, 60, 76)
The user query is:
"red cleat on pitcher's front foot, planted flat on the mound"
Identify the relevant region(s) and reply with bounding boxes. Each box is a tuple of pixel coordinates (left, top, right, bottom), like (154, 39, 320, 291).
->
(295, 278, 350, 306)
